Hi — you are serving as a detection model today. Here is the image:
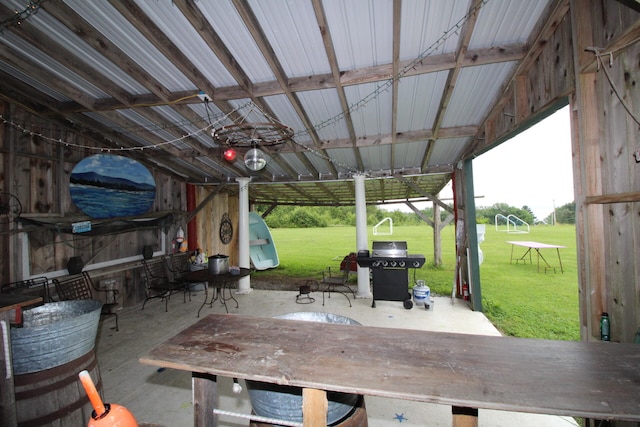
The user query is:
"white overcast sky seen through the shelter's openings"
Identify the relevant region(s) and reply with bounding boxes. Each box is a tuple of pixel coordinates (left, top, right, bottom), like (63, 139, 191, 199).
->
(386, 107, 574, 220)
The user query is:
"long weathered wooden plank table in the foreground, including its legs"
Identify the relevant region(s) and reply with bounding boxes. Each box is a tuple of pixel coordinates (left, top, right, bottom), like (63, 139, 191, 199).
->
(140, 315, 640, 427)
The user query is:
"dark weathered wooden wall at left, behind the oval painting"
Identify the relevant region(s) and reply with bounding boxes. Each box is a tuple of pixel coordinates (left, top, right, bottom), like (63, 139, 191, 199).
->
(0, 104, 192, 305)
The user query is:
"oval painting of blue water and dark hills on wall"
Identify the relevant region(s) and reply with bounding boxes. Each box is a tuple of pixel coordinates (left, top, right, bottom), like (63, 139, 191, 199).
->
(69, 154, 156, 219)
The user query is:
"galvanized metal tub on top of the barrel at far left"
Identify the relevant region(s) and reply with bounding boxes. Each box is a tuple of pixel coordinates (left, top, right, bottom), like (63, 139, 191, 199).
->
(11, 300, 102, 375)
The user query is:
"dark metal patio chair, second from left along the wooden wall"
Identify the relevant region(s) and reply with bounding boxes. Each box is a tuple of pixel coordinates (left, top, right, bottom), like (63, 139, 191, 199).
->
(53, 271, 120, 331)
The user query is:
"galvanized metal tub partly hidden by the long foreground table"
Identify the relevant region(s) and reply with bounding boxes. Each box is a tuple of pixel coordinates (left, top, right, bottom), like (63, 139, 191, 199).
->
(246, 312, 361, 425)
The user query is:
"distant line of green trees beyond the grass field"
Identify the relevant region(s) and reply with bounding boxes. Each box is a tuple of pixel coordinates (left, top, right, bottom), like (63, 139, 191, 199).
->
(256, 202, 575, 228)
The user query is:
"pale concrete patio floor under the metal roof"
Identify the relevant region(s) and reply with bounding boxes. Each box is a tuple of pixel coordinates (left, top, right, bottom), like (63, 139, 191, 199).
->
(96, 289, 578, 427)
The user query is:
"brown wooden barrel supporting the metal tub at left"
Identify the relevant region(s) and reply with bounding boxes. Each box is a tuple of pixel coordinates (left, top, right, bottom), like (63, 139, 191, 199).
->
(14, 349, 102, 427)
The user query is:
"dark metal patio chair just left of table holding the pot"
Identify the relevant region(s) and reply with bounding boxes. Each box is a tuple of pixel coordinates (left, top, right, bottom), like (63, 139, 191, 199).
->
(142, 257, 191, 311)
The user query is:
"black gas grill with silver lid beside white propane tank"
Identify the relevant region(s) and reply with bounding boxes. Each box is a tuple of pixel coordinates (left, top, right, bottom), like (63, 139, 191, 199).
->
(356, 241, 425, 309)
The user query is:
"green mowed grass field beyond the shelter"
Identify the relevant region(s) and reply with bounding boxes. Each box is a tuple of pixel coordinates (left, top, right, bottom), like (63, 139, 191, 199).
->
(252, 225, 580, 340)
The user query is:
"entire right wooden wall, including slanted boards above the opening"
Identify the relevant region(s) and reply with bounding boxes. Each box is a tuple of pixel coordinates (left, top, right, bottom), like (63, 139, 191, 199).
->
(464, 0, 640, 352)
